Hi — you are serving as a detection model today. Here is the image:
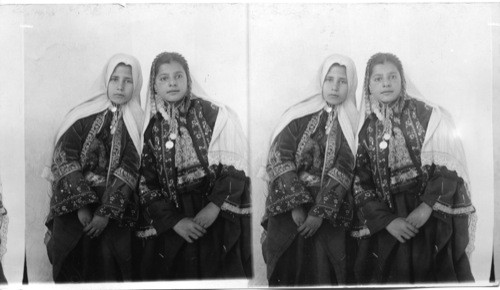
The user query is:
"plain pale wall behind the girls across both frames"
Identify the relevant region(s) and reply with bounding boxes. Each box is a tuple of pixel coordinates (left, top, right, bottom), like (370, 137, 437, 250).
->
(17, 4, 493, 285)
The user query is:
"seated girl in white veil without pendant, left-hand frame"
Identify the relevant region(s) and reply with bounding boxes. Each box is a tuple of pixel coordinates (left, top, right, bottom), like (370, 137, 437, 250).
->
(46, 54, 143, 282)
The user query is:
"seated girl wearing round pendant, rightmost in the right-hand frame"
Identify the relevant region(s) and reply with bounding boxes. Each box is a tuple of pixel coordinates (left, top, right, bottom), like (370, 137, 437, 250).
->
(354, 53, 475, 283)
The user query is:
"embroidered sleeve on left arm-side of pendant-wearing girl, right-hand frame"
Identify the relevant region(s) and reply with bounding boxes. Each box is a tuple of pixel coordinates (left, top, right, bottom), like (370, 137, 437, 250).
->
(353, 131, 397, 234)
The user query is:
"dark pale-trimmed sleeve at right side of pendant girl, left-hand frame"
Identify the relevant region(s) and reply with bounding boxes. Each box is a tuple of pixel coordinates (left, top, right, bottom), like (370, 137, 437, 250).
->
(208, 164, 251, 219)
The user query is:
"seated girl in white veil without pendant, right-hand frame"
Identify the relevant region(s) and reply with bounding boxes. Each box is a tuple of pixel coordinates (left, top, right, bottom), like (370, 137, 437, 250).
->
(262, 55, 357, 286)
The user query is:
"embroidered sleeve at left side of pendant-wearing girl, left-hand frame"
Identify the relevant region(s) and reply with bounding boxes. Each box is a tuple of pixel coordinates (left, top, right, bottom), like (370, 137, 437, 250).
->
(139, 119, 184, 234)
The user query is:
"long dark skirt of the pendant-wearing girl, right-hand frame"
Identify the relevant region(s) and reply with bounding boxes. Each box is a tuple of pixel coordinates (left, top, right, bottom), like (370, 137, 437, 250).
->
(355, 191, 474, 284)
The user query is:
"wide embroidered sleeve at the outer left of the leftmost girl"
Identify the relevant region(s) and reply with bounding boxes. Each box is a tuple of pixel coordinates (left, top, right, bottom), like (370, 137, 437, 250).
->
(50, 120, 99, 216)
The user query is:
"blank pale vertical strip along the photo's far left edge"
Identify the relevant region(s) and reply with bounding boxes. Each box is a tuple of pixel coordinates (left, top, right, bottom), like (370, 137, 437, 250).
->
(0, 7, 25, 284)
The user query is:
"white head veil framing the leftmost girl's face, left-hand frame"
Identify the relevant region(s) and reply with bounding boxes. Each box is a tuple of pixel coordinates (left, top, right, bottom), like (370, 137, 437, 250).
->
(42, 53, 143, 180)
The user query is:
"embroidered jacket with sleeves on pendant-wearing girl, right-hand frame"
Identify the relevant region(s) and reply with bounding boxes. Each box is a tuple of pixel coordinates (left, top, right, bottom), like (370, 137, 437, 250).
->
(353, 96, 474, 237)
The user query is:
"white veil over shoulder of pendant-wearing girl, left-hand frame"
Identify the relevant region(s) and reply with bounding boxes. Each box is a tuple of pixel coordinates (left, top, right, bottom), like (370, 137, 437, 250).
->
(141, 52, 248, 175)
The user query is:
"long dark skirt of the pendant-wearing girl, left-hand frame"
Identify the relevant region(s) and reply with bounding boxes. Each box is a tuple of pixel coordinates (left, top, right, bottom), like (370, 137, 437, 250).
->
(134, 191, 252, 281)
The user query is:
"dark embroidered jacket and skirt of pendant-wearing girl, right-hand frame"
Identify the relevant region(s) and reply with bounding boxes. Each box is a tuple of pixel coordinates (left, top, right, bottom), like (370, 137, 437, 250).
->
(354, 97, 474, 284)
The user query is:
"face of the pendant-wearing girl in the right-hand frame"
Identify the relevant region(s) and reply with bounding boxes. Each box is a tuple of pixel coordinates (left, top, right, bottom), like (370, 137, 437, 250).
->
(370, 61, 401, 104)
